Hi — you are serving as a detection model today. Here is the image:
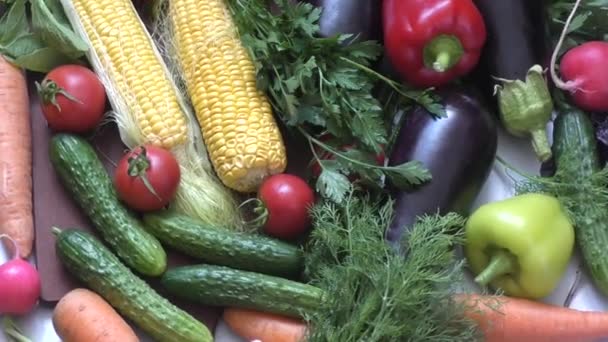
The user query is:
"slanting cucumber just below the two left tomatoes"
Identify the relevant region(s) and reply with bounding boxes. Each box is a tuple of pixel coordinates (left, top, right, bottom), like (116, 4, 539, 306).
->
(49, 134, 167, 276)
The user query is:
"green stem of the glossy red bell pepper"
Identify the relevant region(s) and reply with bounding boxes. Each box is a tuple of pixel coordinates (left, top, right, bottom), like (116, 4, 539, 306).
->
(424, 34, 464, 72)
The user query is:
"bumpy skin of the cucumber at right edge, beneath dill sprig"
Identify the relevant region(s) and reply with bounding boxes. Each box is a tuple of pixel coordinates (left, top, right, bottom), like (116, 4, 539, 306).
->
(553, 109, 608, 295)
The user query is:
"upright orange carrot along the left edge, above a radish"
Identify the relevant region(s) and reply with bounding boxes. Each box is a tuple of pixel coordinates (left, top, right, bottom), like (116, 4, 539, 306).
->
(0, 55, 34, 258)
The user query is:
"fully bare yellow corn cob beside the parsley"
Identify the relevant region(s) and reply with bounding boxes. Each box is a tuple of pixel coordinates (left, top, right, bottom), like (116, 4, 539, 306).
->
(169, 0, 287, 192)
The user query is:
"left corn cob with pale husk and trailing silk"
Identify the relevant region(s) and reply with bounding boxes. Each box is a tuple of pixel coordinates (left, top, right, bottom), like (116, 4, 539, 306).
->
(61, 0, 238, 226)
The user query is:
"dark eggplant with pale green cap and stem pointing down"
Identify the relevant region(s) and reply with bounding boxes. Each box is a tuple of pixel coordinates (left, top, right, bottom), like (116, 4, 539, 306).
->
(475, 0, 553, 162)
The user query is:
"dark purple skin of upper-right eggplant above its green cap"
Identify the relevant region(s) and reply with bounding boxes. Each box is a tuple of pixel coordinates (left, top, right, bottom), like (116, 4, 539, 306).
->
(473, 0, 551, 102)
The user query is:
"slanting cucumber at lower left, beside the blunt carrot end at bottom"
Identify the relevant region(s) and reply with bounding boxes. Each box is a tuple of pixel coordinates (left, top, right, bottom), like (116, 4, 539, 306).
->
(53, 228, 213, 342)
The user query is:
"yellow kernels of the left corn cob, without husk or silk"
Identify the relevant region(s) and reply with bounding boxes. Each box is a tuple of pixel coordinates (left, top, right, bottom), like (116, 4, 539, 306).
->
(72, 0, 188, 149)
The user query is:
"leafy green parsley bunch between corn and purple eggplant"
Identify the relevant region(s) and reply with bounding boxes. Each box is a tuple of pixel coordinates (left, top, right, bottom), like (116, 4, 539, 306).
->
(226, 0, 444, 202)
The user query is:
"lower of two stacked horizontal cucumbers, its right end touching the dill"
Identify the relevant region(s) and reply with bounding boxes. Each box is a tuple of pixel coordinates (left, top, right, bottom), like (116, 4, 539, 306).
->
(161, 265, 324, 318)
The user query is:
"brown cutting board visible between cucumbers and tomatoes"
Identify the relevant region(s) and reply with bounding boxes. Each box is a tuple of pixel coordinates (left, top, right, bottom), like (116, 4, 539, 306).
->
(30, 74, 220, 330)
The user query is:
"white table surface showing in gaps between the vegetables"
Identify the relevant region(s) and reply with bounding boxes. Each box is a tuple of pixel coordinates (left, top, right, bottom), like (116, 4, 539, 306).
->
(0, 127, 608, 342)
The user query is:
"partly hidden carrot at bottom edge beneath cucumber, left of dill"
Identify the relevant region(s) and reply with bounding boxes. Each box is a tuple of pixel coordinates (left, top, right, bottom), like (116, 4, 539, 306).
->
(223, 308, 306, 342)
